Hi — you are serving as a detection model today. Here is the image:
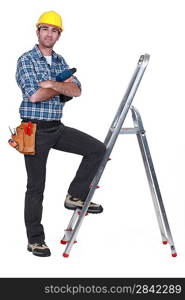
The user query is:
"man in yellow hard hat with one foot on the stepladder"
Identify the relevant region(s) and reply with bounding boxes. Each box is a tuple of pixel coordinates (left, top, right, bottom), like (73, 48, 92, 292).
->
(16, 11, 106, 257)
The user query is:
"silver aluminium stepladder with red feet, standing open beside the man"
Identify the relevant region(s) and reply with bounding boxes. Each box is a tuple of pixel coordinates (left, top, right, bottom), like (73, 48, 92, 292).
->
(61, 54, 177, 257)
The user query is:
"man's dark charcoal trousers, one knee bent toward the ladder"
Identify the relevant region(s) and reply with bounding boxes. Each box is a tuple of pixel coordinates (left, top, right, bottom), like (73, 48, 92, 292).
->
(24, 123, 106, 243)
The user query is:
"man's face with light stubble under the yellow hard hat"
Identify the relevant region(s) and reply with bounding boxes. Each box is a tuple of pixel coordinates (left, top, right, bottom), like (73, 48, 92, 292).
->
(37, 24, 60, 48)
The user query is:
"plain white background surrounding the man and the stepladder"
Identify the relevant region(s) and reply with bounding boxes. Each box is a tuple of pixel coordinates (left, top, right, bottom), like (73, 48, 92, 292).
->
(0, 0, 185, 277)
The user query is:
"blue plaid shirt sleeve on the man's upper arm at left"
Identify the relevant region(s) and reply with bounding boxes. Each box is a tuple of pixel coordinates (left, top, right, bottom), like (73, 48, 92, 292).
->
(16, 57, 40, 97)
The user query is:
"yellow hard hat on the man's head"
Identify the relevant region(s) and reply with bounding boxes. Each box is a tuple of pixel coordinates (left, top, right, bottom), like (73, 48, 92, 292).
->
(36, 10, 64, 31)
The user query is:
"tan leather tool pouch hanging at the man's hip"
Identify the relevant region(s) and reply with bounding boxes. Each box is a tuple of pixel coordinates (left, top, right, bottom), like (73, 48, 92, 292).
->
(12, 122, 37, 155)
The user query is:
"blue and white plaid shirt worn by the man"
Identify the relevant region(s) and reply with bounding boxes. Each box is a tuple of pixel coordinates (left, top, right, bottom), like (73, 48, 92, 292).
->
(16, 45, 81, 121)
